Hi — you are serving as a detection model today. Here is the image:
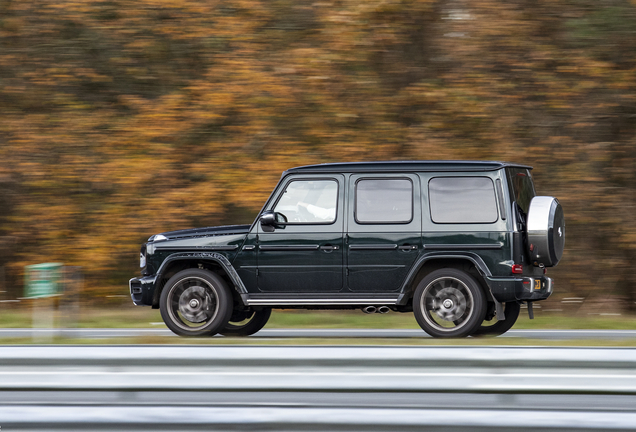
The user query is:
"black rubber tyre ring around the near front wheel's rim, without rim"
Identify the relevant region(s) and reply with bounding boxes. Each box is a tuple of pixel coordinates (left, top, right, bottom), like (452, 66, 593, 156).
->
(159, 269, 232, 336)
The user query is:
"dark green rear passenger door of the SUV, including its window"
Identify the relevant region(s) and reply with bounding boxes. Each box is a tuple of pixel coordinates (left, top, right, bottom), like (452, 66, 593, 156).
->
(346, 174, 422, 292)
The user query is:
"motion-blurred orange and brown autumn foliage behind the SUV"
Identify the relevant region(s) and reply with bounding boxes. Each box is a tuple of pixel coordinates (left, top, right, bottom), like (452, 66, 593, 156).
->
(0, 0, 636, 314)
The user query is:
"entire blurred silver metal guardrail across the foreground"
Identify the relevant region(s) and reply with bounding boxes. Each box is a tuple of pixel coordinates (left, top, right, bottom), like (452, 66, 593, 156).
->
(0, 346, 636, 431)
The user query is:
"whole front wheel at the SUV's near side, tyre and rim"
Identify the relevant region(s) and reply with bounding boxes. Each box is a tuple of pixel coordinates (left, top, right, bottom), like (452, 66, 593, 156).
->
(159, 269, 232, 336)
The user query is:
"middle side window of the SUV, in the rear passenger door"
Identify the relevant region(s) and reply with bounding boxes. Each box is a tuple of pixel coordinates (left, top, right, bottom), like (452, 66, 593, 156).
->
(356, 179, 413, 223)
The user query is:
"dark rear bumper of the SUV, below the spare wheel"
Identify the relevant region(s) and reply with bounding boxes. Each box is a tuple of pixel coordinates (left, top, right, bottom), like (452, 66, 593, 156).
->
(486, 276, 554, 302)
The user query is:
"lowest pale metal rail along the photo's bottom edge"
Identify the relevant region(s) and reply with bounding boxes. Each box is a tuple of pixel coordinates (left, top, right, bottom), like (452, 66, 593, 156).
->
(0, 407, 636, 432)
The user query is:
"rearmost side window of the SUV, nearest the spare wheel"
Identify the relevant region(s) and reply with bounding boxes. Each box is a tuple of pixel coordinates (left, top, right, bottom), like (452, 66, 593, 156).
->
(428, 177, 498, 223)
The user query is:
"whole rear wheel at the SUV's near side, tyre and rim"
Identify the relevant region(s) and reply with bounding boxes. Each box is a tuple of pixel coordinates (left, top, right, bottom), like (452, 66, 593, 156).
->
(413, 268, 486, 338)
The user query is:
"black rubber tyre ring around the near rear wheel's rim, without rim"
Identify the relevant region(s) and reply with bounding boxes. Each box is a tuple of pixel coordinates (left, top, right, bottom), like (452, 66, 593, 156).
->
(413, 268, 486, 338)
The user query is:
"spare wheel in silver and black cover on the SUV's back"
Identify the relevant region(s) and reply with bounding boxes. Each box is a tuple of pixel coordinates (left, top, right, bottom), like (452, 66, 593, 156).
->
(527, 196, 565, 267)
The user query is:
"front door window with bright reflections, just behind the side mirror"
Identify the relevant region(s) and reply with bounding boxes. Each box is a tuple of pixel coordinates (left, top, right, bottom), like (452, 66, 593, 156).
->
(274, 180, 338, 224)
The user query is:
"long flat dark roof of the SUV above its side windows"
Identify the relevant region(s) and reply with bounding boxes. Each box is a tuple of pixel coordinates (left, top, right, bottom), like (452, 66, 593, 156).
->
(283, 160, 532, 174)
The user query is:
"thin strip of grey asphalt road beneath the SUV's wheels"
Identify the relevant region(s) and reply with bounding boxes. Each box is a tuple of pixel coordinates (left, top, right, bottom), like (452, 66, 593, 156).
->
(0, 325, 636, 340)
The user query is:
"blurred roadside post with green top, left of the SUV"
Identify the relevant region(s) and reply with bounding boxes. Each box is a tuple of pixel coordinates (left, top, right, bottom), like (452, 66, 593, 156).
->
(24, 263, 63, 342)
